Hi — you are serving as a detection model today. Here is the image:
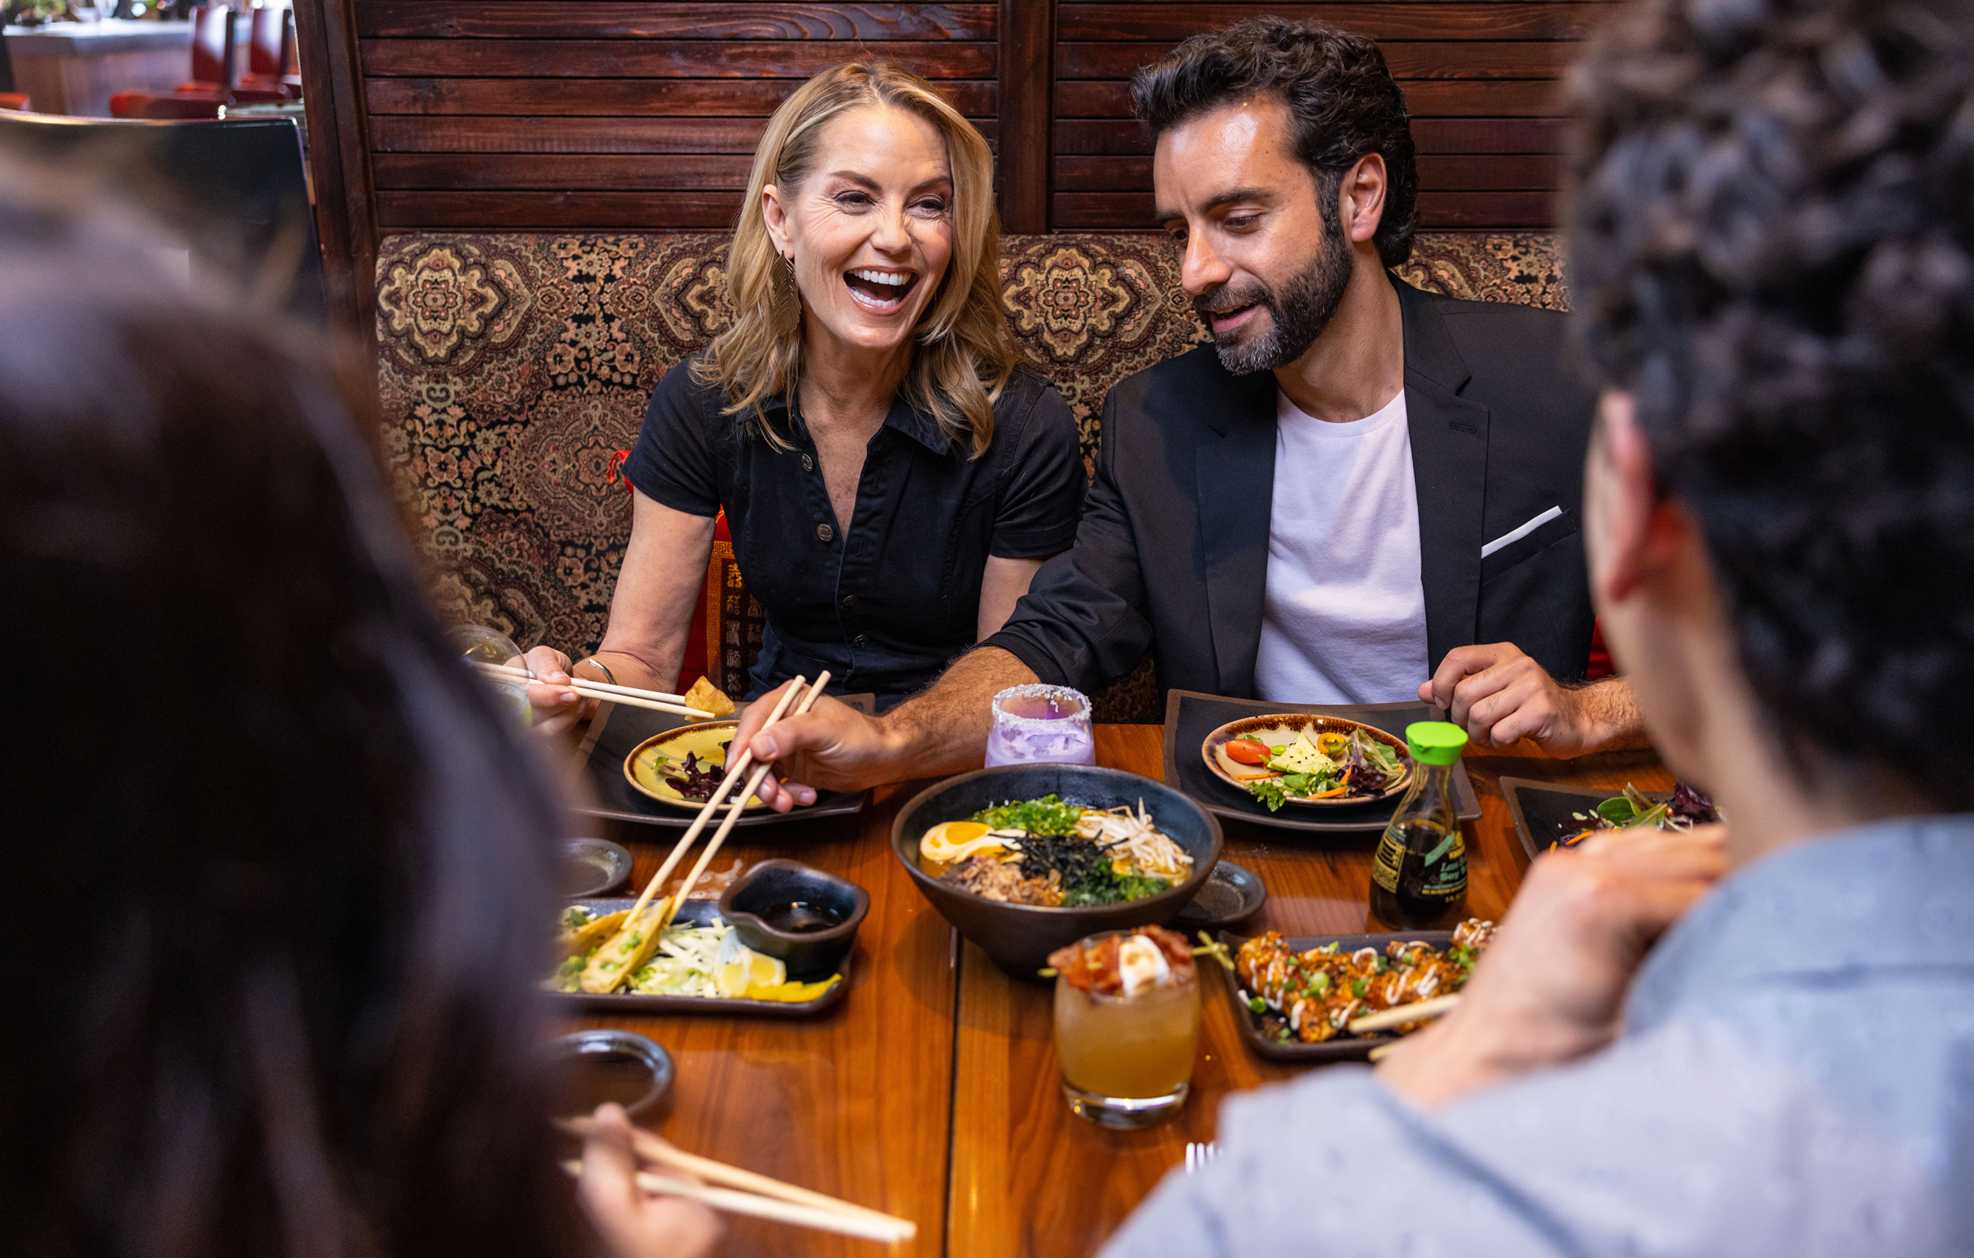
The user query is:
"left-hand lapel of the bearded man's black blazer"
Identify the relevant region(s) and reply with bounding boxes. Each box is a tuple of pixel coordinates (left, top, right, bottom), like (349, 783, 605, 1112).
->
(1192, 371, 1275, 695)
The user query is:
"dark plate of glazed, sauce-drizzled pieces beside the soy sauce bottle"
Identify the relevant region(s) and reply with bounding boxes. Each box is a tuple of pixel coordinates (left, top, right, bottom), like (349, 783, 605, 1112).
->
(1220, 918, 1494, 1064)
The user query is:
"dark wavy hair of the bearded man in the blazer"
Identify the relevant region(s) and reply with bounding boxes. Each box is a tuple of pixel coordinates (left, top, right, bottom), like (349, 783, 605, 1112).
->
(1131, 18, 1419, 267)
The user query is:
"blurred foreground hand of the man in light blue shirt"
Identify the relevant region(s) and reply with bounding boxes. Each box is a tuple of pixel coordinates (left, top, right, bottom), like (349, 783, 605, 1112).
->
(1378, 826, 1727, 1106)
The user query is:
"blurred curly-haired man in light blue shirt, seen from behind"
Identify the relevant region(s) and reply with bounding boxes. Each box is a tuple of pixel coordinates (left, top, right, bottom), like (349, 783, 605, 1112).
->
(1105, 0, 1974, 1258)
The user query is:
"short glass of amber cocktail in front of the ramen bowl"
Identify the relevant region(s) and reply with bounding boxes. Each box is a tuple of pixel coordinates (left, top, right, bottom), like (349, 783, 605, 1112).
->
(1056, 930, 1200, 1130)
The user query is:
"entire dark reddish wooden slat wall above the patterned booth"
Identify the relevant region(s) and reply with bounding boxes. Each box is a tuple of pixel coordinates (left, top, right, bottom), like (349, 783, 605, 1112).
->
(294, 0, 1609, 326)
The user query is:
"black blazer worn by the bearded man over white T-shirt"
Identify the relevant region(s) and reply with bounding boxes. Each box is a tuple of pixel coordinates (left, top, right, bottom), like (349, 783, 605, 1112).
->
(987, 280, 1593, 695)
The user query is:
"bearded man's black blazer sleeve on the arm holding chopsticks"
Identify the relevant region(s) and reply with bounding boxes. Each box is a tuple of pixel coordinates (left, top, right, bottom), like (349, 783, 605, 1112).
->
(983, 395, 1151, 693)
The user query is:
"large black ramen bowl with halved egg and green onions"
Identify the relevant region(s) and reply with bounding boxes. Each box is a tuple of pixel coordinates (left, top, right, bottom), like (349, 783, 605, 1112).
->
(890, 764, 1222, 980)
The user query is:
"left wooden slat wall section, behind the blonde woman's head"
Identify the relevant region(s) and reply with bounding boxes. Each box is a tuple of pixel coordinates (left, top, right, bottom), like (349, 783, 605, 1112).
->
(353, 0, 1001, 231)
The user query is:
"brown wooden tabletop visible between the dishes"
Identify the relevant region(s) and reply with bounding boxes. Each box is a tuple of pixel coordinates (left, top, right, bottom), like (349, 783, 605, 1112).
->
(580, 725, 1672, 1258)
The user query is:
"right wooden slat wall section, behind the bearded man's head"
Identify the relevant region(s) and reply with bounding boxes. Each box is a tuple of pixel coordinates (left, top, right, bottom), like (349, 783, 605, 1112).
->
(1048, 0, 1607, 229)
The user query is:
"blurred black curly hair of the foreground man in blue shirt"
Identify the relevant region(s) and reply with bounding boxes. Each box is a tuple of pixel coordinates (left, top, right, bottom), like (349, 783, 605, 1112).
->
(1569, 0, 1974, 808)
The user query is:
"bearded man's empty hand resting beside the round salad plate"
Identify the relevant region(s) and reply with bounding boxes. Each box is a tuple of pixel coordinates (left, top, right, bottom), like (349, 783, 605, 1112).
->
(1419, 642, 1642, 758)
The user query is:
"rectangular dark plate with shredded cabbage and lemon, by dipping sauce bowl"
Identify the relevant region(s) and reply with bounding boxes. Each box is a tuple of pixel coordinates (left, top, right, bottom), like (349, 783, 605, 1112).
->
(543, 897, 853, 1017)
